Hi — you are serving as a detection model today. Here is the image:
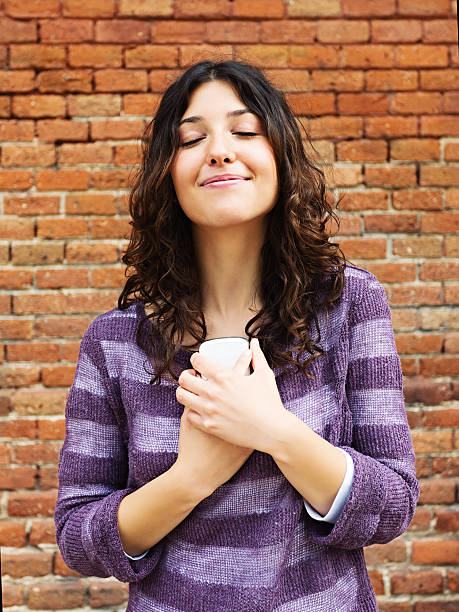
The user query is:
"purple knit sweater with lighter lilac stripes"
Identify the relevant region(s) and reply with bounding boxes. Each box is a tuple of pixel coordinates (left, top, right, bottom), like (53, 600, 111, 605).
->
(55, 264, 419, 612)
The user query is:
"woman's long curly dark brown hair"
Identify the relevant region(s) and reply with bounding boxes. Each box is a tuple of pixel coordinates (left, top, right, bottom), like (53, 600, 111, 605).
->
(118, 61, 346, 384)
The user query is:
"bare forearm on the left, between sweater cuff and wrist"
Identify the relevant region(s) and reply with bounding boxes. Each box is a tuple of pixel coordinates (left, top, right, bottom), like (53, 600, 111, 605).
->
(118, 465, 206, 556)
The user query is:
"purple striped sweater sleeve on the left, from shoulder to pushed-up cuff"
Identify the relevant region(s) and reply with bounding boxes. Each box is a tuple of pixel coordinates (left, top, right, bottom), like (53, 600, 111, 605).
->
(54, 322, 162, 582)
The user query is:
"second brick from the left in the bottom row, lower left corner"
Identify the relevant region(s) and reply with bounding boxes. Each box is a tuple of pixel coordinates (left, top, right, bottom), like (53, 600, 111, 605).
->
(27, 581, 86, 610)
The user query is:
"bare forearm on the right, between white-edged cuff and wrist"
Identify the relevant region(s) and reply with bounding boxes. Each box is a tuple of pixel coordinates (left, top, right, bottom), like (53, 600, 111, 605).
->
(267, 411, 346, 515)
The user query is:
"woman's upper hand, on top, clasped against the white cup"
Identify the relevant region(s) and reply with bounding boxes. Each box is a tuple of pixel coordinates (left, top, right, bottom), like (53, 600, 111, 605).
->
(176, 339, 288, 452)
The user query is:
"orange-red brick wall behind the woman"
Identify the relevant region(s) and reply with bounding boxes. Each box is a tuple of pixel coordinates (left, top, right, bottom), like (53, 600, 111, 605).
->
(0, 0, 459, 612)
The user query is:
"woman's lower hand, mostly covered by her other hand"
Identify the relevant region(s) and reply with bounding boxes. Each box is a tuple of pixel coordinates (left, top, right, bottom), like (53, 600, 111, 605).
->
(175, 370, 253, 497)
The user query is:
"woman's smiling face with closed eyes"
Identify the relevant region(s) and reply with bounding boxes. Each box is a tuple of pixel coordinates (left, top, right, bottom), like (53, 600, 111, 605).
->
(171, 81, 278, 228)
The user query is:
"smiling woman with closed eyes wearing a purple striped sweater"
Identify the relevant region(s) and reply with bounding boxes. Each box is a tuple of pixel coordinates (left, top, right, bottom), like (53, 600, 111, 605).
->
(55, 61, 419, 612)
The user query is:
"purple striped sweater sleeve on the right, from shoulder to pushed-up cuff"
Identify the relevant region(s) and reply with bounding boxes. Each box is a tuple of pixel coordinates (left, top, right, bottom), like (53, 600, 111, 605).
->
(306, 272, 419, 549)
